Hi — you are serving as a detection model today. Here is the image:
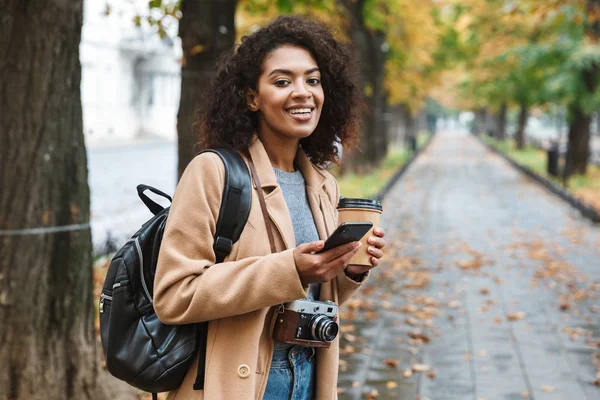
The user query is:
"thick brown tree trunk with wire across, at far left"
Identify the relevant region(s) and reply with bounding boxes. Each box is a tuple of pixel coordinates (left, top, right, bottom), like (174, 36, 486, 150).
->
(0, 0, 101, 400)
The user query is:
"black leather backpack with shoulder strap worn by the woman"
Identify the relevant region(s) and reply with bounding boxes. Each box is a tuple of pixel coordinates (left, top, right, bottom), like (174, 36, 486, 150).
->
(99, 148, 252, 398)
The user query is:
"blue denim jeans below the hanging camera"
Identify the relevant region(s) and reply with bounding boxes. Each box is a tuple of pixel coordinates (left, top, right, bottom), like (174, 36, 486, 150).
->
(263, 346, 316, 400)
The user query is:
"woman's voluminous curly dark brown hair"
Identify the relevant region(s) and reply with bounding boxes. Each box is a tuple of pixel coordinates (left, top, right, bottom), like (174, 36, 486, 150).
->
(197, 16, 364, 166)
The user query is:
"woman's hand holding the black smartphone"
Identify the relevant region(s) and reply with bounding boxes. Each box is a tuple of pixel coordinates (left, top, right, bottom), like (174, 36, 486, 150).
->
(294, 240, 362, 286)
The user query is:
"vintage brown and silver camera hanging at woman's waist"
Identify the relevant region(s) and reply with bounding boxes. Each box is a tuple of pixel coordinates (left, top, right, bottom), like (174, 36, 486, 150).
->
(273, 299, 339, 347)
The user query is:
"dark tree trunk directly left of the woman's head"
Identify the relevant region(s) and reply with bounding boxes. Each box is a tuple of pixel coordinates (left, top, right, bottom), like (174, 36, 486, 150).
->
(177, 0, 237, 178)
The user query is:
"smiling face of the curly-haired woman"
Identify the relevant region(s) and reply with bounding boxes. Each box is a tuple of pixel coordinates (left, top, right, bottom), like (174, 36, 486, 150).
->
(247, 45, 325, 144)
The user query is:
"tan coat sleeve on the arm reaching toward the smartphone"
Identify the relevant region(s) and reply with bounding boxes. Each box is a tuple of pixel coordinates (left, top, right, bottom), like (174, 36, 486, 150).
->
(154, 153, 307, 324)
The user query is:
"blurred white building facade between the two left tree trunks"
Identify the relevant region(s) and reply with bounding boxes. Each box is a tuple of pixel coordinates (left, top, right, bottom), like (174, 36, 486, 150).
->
(80, 0, 181, 147)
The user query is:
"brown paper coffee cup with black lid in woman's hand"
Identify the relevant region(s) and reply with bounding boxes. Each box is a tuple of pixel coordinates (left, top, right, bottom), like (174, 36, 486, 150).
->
(337, 197, 383, 267)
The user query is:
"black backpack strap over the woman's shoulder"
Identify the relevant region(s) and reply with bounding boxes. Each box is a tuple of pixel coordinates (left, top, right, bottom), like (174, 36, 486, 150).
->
(202, 147, 252, 263)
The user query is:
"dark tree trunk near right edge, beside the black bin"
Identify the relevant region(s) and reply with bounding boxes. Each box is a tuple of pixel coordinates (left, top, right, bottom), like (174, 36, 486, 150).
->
(567, 105, 592, 175)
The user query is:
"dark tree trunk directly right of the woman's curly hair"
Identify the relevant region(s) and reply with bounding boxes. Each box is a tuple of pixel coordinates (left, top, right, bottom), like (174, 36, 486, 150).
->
(340, 0, 389, 172)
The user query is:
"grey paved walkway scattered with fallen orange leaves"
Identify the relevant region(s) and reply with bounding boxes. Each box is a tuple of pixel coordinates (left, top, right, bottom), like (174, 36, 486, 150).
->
(339, 132, 600, 400)
